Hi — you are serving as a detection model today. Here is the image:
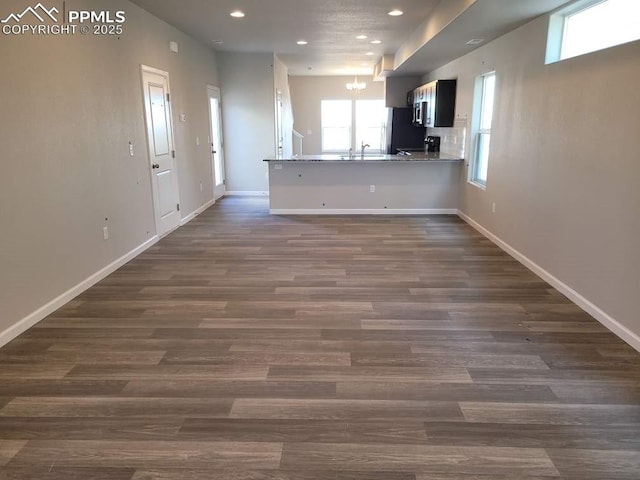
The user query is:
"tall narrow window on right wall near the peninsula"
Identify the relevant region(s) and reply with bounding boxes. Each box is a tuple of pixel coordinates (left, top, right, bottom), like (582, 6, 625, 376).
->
(470, 72, 496, 188)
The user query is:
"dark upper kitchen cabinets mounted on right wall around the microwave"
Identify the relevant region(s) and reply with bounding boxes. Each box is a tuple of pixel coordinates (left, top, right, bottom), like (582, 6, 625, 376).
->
(413, 80, 457, 128)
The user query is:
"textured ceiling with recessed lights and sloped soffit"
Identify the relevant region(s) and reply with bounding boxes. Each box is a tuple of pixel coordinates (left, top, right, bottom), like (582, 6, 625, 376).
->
(131, 0, 567, 76)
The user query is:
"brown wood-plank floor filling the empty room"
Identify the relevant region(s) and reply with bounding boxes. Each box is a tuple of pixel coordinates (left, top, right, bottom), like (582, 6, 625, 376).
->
(0, 198, 640, 480)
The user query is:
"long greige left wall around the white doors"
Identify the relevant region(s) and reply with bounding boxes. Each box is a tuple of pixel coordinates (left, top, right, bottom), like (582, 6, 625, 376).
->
(0, 0, 218, 341)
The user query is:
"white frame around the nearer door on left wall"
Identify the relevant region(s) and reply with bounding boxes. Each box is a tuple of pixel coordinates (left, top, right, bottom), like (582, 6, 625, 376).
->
(140, 64, 182, 238)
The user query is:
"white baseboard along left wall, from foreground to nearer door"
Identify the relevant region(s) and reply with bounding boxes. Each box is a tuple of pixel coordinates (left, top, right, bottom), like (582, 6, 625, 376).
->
(0, 235, 159, 347)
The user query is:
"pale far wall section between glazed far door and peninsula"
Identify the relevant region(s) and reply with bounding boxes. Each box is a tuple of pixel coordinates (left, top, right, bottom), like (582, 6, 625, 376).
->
(217, 52, 276, 193)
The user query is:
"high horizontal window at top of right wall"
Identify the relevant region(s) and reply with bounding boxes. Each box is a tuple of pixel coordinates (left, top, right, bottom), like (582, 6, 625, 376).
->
(546, 0, 640, 63)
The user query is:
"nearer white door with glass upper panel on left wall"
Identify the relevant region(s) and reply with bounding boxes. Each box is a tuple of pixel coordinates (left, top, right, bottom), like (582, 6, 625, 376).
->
(142, 66, 180, 236)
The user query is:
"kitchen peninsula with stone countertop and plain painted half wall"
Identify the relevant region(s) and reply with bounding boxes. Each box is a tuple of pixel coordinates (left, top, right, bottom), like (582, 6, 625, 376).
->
(264, 153, 462, 214)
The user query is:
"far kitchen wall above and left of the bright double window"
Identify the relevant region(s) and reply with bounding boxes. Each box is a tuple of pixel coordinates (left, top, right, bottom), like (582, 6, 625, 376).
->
(289, 76, 384, 154)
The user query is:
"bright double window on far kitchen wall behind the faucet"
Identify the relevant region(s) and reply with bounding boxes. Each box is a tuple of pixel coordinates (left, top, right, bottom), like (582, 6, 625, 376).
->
(320, 100, 387, 153)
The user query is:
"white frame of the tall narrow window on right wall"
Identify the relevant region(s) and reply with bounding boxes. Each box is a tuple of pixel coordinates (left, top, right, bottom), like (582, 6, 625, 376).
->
(468, 70, 498, 190)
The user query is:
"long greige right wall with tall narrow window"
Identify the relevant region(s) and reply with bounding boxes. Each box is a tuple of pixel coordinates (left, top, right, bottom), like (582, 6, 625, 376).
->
(424, 17, 640, 347)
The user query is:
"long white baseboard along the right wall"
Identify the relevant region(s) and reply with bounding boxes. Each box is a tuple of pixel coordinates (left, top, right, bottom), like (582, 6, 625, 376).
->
(458, 211, 640, 352)
